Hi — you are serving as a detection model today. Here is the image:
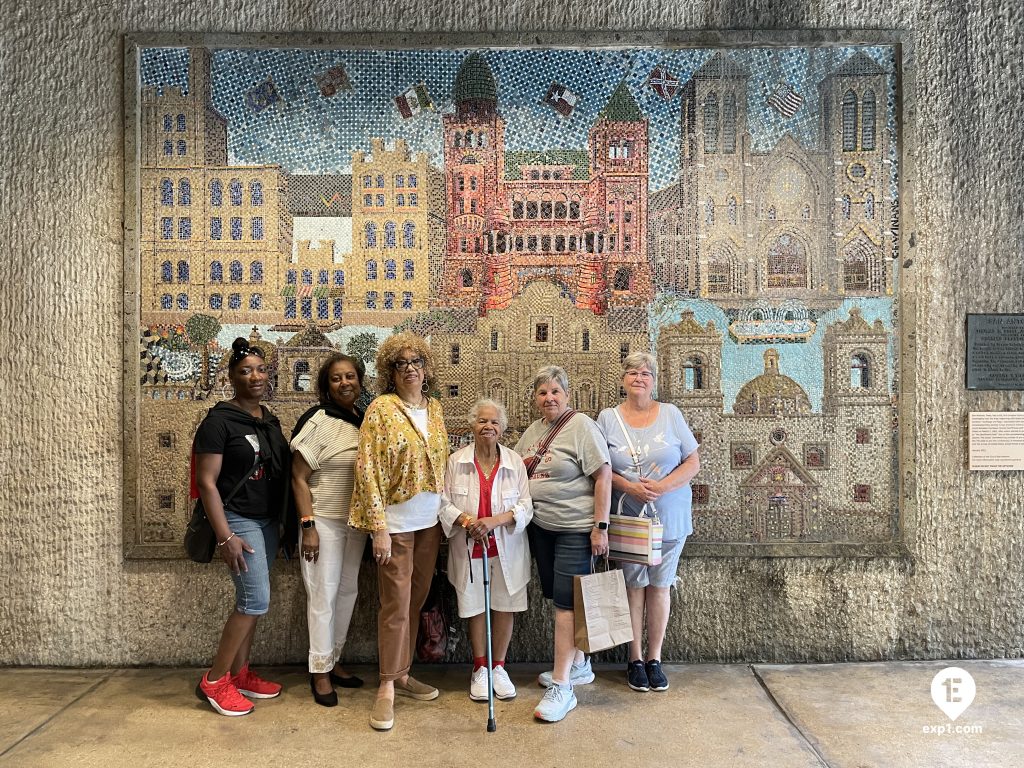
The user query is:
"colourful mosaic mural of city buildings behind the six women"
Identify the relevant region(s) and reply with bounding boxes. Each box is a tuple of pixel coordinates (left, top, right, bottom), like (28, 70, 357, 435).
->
(126, 45, 899, 557)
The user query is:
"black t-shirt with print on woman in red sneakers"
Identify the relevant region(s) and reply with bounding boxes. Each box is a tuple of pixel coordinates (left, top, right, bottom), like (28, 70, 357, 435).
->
(193, 409, 280, 519)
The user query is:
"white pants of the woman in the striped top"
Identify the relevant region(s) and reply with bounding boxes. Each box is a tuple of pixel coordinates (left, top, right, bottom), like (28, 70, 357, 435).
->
(299, 517, 367, 673)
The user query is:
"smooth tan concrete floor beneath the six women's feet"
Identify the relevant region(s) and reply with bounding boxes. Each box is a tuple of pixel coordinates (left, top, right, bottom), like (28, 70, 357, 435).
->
(0, 662, 1024, 768)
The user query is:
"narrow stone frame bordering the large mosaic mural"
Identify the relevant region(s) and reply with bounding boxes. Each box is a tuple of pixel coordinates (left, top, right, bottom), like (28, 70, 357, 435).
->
(122, 30, 916, 560)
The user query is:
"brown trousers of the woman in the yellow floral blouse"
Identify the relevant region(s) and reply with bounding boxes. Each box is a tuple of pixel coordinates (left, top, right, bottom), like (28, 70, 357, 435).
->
(377, 523, 441, 682)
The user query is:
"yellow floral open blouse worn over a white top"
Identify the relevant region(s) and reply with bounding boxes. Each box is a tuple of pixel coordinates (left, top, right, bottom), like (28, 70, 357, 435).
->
(348, 394, 449, 530)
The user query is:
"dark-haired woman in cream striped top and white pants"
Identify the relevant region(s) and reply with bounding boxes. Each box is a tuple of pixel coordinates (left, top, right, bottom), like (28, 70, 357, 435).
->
(292, 354, 367, 707)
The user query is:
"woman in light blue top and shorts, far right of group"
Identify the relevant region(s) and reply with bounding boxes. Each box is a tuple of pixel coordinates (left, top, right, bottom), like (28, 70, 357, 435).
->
(597, 352, 700, 691)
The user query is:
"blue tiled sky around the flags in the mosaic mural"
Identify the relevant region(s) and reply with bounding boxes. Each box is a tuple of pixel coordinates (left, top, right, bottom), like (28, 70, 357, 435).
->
(141, 46, 894, 189)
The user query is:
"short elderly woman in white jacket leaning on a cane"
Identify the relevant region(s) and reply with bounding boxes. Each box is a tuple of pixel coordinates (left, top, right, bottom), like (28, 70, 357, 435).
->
(440, 399, 534, 701)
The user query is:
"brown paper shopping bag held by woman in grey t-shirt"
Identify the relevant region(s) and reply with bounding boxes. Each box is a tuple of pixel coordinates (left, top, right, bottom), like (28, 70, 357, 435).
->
(572, 559, 633, 653)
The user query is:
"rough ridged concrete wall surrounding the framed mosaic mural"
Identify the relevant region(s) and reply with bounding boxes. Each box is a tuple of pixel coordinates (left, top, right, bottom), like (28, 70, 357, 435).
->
(0, 0, 1024, 665)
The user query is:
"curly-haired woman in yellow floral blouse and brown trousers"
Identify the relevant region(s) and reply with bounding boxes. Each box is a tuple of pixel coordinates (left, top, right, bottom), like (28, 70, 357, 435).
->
(348, 333, 449, 730)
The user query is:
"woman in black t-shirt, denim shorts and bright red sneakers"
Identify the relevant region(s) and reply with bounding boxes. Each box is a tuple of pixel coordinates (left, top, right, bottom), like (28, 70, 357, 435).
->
(193, 338, 290, 717)
